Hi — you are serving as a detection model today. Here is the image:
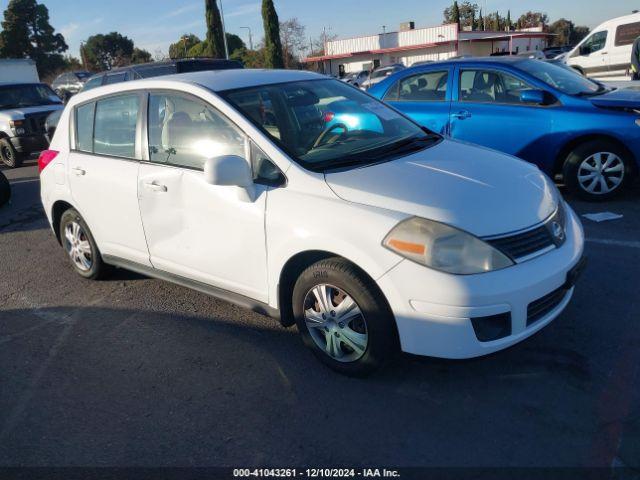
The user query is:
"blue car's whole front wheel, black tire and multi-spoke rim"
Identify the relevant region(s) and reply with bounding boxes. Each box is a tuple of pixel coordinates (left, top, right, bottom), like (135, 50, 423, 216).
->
(563, 141, 632, 201)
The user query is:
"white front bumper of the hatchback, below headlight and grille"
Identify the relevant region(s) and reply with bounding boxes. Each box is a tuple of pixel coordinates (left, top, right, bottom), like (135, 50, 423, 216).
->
(378, 207, 584, 359)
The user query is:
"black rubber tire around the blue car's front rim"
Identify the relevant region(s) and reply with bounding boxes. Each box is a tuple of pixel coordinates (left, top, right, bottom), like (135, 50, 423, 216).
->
(562, 140, 633, 202)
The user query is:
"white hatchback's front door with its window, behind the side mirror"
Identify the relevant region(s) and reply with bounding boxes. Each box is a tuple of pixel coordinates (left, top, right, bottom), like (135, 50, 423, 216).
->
(138, 92, 268, 302)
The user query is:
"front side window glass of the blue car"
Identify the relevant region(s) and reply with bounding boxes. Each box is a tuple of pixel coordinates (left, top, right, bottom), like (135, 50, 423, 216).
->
(460, 70, 531, 104)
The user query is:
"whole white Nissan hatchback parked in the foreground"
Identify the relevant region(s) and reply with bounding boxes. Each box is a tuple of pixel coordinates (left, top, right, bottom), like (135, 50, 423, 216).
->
(39, 70, 584, 375)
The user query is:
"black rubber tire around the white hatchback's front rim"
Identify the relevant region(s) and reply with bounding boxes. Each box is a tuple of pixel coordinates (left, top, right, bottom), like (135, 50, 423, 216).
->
(292, 257, 399, 376)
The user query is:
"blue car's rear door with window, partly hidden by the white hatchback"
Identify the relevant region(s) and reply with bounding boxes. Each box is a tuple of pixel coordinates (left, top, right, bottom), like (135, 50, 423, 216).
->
(383, 67, 452, 134)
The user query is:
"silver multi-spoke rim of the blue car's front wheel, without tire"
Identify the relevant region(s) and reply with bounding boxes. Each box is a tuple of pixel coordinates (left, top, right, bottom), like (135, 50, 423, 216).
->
(578, 152, 625, 195)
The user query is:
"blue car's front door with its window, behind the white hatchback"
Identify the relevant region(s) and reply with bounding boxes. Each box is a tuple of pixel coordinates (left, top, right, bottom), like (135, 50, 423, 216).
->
(450, 67, 553, 162)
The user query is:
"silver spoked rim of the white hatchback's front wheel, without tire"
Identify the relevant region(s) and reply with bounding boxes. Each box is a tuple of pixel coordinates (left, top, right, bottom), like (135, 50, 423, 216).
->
(304, 284, 369, 363)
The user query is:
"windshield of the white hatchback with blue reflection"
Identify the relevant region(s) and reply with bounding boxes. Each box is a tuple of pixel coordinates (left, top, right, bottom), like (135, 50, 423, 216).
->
(223, 80, 440, 171)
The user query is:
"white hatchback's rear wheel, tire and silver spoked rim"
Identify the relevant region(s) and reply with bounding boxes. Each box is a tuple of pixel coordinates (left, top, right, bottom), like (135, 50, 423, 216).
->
(60, 209, 107, 280)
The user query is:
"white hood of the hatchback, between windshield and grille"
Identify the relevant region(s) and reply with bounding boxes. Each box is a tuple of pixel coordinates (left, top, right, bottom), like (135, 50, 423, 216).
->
(325, 140, 558, 237)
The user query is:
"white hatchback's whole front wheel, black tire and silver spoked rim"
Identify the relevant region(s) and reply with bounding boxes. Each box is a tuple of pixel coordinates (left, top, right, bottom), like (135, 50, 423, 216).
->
(292, 258, 398, 376)
